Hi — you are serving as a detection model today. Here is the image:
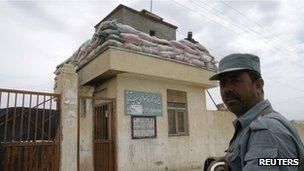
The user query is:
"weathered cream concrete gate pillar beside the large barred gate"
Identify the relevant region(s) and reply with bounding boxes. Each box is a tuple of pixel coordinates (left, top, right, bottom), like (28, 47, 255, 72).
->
(54, 64, 78, 171)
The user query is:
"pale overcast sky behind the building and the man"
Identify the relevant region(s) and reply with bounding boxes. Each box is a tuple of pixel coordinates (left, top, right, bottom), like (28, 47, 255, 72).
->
(0, 0, 304, 120)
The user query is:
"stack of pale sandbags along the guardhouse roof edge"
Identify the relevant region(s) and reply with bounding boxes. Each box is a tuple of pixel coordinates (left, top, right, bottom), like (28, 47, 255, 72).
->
(57, 20, 217, 74)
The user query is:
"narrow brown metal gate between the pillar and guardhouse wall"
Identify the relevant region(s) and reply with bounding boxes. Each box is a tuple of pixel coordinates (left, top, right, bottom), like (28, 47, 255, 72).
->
(79, 96, 116, 171)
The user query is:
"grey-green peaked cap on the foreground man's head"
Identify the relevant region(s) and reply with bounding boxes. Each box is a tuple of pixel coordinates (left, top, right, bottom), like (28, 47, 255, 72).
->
(209, 53, 261, 80)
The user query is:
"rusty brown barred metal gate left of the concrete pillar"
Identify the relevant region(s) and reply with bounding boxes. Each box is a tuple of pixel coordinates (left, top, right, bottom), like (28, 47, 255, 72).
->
(0, 89, 60, 171)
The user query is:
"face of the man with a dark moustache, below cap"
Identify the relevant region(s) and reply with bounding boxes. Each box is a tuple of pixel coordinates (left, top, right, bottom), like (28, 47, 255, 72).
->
(220, 71, 260, 117)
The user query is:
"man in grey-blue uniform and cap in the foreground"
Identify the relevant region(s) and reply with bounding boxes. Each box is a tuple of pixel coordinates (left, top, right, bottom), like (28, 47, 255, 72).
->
(210, 54, 304, 171)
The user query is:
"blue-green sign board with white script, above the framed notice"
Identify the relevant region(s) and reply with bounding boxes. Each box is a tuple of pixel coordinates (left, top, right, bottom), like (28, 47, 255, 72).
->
(124, 90, 163, 116)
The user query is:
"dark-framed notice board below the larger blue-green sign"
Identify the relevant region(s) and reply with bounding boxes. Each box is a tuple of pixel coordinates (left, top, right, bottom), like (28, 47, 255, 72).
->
(131, 116, 156, 139)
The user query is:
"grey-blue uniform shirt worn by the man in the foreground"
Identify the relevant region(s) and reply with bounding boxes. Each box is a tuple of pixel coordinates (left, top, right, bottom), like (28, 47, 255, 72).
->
(226, 100, 304, 171)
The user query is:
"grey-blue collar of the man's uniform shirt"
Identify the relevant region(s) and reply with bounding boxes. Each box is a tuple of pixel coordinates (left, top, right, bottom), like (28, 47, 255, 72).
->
(233, 100, 271, 129)
